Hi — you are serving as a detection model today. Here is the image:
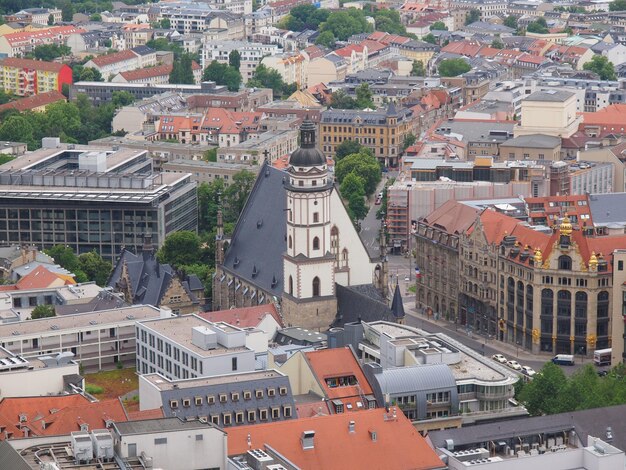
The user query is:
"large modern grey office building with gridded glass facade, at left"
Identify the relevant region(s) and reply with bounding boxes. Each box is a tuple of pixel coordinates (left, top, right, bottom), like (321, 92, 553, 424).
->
(0, 138, 198, 260)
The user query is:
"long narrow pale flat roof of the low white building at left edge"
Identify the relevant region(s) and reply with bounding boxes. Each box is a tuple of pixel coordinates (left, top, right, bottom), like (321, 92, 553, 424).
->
(0, 305, 161, 341)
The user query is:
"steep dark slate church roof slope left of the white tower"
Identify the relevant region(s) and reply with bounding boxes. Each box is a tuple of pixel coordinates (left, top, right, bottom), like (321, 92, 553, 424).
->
(223, 163, 287, 297)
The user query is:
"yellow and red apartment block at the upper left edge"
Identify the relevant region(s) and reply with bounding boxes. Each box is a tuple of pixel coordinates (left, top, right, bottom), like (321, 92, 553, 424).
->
(0, 57, 72, 96)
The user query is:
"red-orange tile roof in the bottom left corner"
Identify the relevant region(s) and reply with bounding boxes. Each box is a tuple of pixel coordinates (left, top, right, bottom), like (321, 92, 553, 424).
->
(0, 394, 128, 440)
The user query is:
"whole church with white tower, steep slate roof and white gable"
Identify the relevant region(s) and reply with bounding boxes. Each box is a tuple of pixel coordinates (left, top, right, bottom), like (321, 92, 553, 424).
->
(213, 120, 391, 329)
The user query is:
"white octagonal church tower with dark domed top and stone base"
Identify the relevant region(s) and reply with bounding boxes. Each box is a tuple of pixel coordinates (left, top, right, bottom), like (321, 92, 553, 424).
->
(280, 119, 337, 329)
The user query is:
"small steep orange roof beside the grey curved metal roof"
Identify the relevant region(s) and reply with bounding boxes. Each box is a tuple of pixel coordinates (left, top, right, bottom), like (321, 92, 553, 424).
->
(304, 348, 373, 404)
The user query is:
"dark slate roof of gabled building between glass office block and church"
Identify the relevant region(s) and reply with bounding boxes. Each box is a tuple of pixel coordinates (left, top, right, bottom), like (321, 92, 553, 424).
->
(107, 250, 196, 306)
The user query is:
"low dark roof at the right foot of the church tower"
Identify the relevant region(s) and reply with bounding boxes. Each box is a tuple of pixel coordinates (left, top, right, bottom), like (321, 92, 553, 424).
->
(332, 284, 392, 327)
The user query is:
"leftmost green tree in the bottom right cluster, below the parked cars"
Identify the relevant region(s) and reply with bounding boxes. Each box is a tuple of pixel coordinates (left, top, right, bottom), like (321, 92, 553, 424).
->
(520, 362, 567, 416)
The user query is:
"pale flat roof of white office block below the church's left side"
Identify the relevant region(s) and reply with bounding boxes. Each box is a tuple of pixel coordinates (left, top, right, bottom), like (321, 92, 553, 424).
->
(141, 315, 250, 357)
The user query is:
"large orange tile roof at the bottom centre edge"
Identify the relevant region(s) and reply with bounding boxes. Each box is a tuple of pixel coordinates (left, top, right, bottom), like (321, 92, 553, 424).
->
(226, 408, 445, 470)
